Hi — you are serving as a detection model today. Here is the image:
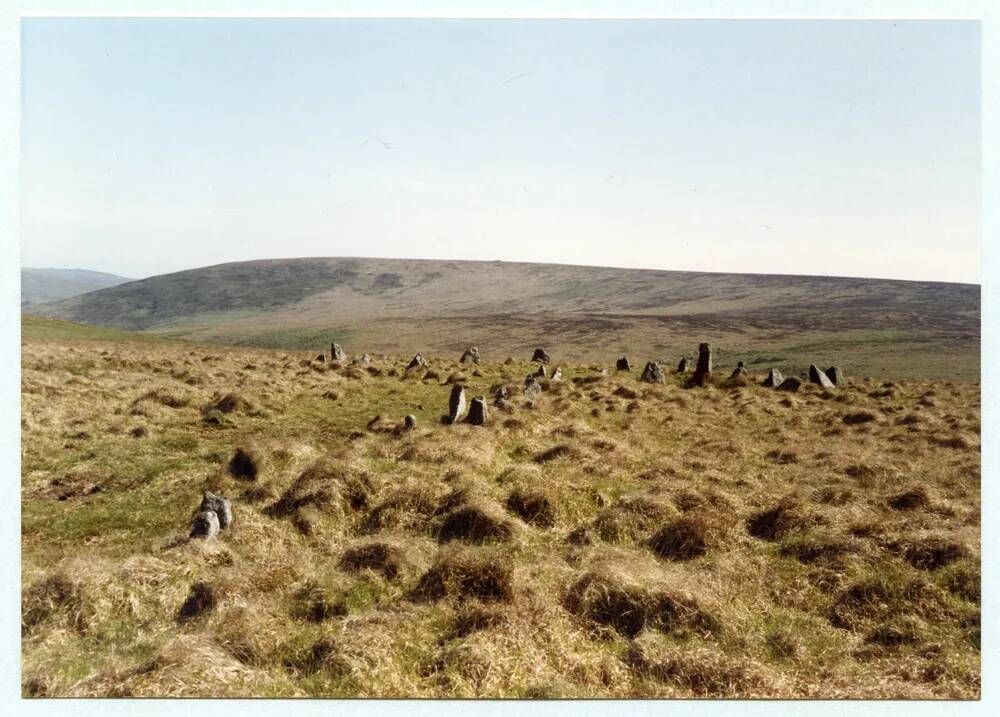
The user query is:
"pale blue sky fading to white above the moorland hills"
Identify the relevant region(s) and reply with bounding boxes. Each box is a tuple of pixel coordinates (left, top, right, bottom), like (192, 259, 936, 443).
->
(20, 18, 981, 283)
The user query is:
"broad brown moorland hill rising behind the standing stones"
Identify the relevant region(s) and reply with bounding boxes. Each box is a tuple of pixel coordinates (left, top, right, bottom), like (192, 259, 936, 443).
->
(25, 258, 980, 379)
